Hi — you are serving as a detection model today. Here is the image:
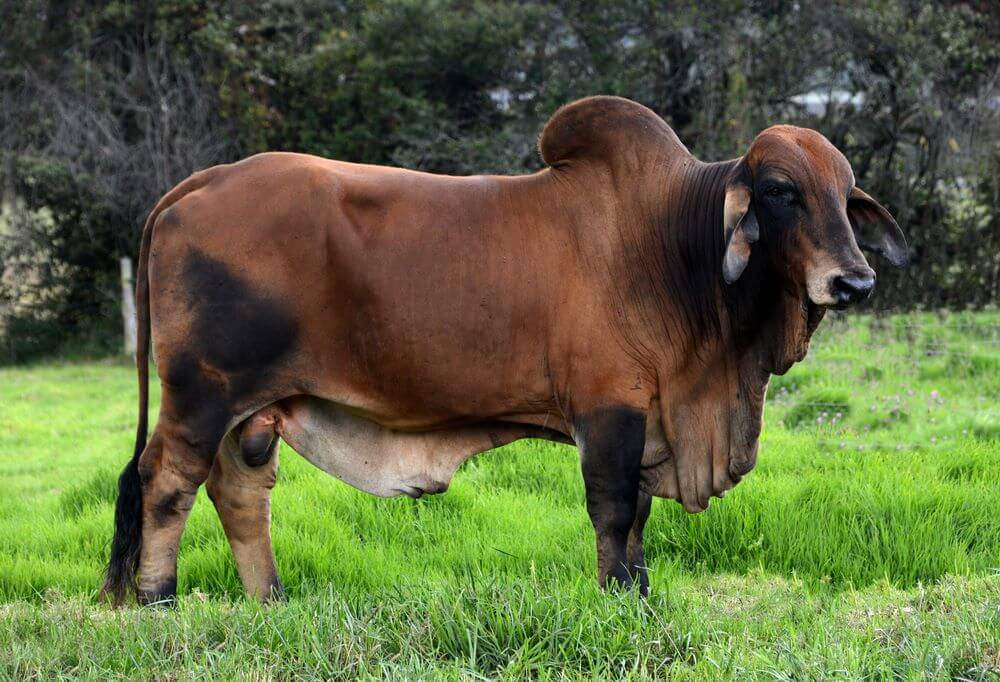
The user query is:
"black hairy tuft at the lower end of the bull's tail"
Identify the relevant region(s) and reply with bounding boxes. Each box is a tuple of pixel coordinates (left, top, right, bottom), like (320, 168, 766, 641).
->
(103, 425, 146, 606)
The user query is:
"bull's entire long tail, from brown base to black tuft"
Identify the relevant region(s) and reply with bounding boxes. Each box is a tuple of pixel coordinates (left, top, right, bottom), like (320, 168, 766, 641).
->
(102, 168, 217, 606)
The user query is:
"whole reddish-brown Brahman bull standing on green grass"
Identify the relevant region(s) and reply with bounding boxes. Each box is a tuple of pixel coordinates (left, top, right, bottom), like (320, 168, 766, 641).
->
(105, 97, 907, 603)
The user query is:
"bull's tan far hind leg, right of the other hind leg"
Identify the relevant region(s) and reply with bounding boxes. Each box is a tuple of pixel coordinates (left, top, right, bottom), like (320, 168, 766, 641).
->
(205, 415, 284, 600)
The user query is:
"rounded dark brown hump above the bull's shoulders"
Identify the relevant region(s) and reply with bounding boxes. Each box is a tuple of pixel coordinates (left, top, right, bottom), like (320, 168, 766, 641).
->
(538, 96, 690, 167)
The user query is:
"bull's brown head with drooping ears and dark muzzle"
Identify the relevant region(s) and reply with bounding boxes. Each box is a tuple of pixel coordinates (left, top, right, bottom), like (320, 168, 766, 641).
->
(723, 126, 908, 308)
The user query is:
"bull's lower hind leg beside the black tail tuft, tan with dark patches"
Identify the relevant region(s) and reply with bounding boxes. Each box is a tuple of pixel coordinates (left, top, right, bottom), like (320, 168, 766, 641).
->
(138, 421, 212, 604)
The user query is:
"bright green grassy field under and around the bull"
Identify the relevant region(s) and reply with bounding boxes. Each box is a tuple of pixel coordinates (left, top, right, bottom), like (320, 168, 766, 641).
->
(0, 314, 1000, 680)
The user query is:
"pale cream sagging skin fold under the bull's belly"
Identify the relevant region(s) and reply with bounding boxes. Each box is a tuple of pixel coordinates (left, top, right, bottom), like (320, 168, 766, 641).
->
(266, 396, 554, 497)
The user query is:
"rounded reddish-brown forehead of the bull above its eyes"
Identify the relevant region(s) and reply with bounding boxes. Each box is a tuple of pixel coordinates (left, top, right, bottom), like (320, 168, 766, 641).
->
(747, 125, 854, 195)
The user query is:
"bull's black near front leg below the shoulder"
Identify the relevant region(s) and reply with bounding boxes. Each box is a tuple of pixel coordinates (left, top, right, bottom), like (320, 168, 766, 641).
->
(574, 407, 648, 594)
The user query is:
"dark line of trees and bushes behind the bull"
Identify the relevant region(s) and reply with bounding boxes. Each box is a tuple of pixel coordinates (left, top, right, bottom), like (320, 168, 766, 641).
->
(0, 0, 1000, 361)
